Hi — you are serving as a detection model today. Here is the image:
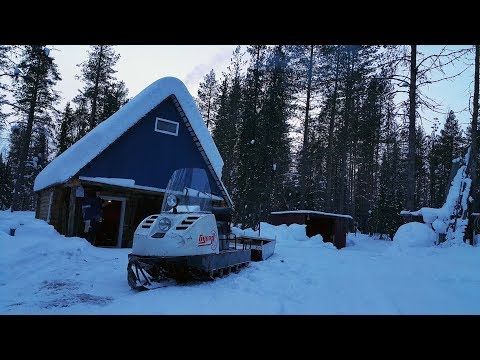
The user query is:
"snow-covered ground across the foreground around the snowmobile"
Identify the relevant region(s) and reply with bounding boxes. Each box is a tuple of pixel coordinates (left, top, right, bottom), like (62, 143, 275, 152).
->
(0, 211, 480, 315)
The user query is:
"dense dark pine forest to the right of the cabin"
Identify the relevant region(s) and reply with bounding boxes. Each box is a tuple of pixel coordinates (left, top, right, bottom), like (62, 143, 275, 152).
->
(197, 45, 480, 240)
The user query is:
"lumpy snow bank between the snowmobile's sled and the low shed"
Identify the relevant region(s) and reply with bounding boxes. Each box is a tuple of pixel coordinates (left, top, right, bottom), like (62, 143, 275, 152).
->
(232, 222, 330, 249)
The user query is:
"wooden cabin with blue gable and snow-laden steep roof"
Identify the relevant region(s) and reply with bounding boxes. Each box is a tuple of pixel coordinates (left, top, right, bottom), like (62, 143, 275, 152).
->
(34, 77, 232, 247)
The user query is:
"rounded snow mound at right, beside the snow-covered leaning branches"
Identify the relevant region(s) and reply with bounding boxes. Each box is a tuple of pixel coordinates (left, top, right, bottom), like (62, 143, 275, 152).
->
(393, 222, 437, 249)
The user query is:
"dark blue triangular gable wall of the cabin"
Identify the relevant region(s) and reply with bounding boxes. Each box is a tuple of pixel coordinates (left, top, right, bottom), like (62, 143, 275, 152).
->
(78, 97, 221, 196)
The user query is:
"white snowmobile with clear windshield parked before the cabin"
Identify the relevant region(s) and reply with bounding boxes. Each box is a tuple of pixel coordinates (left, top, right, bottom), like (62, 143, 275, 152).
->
(127, 168, 251, 290)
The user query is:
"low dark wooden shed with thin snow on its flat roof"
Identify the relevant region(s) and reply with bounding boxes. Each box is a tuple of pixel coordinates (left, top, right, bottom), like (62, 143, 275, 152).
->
(269, 210, 353, 249)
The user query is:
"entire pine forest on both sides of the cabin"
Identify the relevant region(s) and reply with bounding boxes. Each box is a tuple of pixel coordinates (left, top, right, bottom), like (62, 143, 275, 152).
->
(0, 45, 480, 242)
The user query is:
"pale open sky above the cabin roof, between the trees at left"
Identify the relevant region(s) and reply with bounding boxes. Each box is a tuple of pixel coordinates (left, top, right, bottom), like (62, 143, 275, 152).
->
(50, 45, 236, 108)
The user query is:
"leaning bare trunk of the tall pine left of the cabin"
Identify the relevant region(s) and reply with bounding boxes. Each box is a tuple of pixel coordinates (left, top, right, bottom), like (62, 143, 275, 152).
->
(11, 78, 39, 212)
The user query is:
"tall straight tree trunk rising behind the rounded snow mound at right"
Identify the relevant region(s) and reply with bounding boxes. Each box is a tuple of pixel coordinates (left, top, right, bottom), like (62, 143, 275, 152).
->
(406, 45, 418, 211)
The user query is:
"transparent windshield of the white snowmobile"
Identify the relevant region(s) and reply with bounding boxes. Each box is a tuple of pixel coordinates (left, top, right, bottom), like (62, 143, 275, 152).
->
(162, 168, 213, 213)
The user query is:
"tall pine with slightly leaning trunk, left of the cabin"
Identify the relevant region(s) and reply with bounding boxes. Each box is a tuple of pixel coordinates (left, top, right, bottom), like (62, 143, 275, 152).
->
(12, 45, 61, 211)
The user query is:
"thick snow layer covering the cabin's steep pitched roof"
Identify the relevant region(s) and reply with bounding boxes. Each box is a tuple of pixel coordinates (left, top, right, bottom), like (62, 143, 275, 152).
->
(33, 77, 228, 196)
